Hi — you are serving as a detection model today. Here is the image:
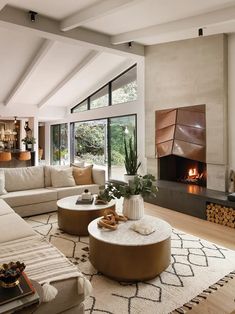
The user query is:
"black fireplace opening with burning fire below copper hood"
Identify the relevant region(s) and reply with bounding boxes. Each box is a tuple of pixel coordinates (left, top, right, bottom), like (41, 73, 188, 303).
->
(158, 155, 206, 186)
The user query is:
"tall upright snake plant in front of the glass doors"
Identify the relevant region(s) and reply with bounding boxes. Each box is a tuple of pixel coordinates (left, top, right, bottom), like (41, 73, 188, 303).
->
(124, 137, 141, 175)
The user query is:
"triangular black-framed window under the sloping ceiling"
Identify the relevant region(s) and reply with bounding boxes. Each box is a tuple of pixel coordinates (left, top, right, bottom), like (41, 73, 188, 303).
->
(71, 64, 137, 113)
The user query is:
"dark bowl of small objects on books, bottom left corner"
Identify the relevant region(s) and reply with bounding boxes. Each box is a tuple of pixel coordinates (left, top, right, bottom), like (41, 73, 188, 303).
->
(0, 261, 25, 288)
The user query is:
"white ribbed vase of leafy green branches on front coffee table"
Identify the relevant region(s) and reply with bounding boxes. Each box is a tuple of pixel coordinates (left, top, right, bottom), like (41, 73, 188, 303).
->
(98, 174, 157, 220)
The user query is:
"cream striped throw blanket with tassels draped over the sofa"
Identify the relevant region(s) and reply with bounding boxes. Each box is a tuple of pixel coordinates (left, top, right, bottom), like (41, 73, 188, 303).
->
(0, 236, 92, 301)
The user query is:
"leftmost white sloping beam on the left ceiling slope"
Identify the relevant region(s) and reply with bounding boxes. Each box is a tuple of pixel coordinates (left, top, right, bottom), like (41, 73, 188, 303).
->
(4, 39, 54, 106)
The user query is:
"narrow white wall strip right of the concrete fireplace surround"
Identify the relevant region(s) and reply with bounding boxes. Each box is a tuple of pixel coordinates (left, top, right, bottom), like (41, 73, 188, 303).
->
(228, 34, 235, 170)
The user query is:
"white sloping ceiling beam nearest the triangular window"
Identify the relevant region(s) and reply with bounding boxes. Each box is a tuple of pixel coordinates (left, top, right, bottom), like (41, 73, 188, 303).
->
(38, 51, 100, 108)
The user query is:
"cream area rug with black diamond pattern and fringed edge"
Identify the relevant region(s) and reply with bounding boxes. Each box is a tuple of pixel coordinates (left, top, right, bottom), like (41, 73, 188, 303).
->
(25, 213, 235, 314)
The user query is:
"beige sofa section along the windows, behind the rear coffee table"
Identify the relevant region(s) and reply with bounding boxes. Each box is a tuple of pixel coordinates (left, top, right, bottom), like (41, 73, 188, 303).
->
(0, 166, 105, 217)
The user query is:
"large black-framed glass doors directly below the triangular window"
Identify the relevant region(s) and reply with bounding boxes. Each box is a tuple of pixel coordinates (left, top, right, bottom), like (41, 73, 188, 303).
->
(71, 115, 136, 180)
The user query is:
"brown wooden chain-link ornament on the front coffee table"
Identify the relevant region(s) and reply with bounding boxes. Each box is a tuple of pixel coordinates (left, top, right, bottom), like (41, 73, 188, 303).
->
(97, 209, 127, 230)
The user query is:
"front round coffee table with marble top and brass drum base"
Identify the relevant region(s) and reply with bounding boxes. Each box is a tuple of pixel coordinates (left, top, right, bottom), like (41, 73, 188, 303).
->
(88, 215, 171, 281)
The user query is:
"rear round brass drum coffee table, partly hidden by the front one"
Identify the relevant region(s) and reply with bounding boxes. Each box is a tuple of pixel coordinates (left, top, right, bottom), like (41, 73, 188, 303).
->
(57, 195, 115, 235)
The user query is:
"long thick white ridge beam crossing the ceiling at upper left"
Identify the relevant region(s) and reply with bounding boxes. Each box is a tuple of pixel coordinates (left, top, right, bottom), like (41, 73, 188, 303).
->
(0, 6, 144, 58)
